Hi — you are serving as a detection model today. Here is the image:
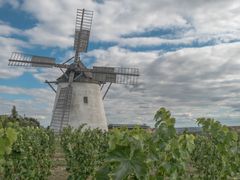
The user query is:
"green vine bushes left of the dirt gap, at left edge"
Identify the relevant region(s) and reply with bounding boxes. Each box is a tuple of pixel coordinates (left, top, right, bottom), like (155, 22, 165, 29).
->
(0, 115, 54, 179)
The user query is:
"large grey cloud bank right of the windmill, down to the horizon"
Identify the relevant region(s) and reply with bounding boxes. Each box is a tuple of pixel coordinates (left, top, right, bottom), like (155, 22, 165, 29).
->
(90, 43, 240, 126)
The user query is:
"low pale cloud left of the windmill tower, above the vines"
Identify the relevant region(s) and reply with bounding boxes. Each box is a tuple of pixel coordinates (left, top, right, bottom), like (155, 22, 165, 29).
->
(0, 86, 55, 126)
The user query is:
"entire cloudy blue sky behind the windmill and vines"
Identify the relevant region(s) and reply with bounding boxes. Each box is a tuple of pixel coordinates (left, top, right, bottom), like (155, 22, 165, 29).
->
(0, 0, 240, 127)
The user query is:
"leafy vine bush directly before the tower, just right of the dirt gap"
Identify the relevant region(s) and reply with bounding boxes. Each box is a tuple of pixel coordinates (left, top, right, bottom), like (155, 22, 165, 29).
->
(60, 125, 108, 179)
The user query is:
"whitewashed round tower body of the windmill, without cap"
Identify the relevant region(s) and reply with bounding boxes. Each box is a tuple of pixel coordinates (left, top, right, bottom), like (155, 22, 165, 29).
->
(50, 82, 108, 132)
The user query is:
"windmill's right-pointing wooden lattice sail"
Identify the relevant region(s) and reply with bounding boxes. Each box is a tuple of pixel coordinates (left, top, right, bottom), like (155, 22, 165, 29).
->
(92, 66, 139, 84)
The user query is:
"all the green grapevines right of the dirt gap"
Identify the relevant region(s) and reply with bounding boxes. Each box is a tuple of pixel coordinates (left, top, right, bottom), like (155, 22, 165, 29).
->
(61, 108, 240, 180)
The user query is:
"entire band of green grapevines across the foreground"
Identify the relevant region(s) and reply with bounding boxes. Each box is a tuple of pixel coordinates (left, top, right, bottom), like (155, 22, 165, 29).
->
(0, 108, 240, 180)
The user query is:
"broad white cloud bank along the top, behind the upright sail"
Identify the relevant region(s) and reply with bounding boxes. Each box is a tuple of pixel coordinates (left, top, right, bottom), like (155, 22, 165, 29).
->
(0, 0, 240, 48)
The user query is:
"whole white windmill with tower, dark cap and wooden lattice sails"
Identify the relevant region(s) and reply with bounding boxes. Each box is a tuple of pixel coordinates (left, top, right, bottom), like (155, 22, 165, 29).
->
(9, 9, 139, 132)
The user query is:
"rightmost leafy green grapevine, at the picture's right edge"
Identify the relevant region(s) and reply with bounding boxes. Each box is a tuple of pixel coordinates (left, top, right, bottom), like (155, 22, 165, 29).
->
(192, 118, 240, 179)
